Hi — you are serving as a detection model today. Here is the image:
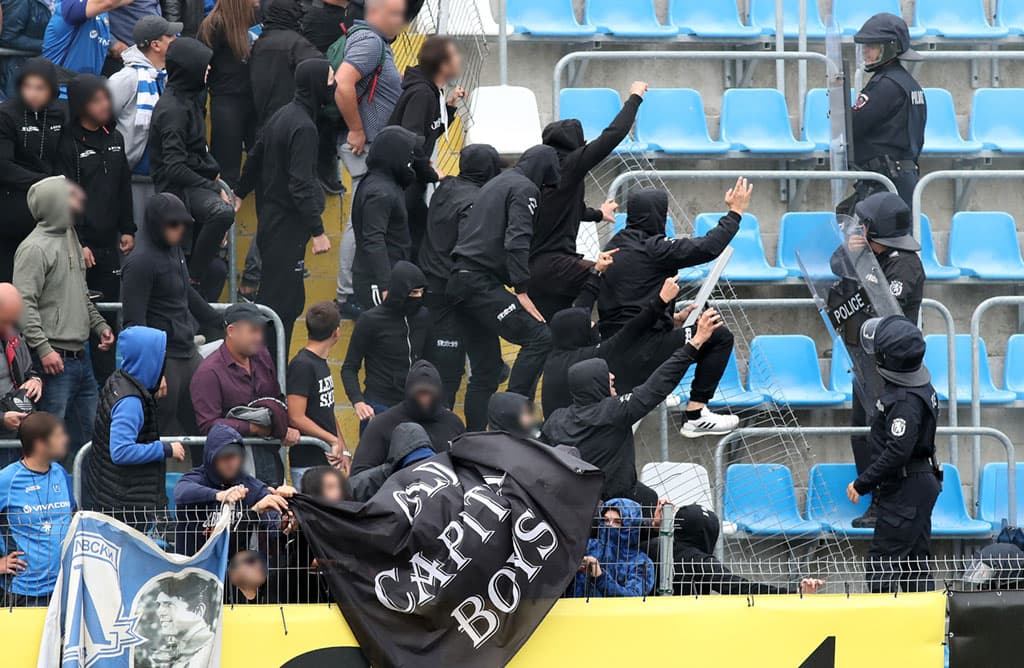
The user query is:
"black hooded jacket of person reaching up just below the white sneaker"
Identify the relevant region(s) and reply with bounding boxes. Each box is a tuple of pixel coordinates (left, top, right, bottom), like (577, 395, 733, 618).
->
(542, 350, 697, 500)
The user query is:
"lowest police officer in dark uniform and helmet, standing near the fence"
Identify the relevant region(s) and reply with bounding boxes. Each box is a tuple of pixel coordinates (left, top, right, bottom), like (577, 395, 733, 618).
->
(846, 316, 942, 592)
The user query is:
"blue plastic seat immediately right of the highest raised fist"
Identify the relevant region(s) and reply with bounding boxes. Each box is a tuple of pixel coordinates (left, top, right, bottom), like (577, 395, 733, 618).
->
(637, 88, 732, 154)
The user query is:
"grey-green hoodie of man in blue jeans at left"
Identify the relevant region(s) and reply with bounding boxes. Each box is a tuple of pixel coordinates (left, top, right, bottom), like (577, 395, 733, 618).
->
(14, 176, 110, 358)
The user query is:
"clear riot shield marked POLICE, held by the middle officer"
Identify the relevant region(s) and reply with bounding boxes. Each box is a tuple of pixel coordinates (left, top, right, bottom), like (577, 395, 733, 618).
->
(794, 216, 903, 423)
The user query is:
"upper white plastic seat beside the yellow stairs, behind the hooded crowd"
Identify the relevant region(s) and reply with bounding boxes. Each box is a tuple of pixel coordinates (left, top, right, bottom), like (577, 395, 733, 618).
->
(466, 86, 541, 154)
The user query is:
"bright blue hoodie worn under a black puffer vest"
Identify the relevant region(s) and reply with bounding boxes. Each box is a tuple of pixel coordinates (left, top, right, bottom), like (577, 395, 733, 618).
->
(111, 327, 171, 466)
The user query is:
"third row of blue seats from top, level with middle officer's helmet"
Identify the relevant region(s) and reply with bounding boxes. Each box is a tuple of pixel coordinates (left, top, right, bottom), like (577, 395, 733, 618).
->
(613, 211, 1024, 283)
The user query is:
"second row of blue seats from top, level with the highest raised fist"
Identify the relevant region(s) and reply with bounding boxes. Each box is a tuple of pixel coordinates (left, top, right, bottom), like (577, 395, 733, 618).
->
(558, 88, 1024, 156)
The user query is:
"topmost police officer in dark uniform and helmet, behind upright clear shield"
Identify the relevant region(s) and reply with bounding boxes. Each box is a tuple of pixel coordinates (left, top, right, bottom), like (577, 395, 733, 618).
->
(837, 13, 928, 213)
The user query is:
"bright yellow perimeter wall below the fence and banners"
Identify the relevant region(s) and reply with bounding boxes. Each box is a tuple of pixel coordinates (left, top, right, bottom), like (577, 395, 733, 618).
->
(0, 592, 945, 668)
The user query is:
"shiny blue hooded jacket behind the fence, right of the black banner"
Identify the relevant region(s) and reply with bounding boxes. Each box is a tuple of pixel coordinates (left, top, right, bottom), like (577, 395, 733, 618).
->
(573, 499, 654, 597)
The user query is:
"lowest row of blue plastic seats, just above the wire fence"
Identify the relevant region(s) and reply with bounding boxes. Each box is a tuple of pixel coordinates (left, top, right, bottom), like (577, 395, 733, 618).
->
(722, 464, 995, 539)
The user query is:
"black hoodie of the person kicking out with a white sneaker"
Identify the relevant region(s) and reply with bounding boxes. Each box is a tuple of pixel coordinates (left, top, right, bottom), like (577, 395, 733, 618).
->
(597, 189, 739, 338)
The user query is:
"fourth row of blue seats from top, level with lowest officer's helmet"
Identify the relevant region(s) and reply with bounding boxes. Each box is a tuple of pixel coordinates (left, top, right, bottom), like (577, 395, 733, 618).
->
(673, 334, 1024, 409)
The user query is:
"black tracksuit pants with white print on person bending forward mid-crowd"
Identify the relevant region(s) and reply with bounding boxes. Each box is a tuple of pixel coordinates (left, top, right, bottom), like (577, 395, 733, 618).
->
(446, 269, 551, 431)
